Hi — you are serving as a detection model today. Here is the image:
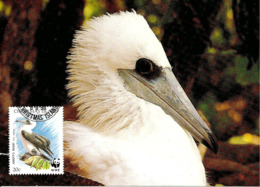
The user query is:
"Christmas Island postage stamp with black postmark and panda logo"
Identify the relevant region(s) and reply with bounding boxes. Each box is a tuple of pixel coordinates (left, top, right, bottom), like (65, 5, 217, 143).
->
(9, 106, 64, 175)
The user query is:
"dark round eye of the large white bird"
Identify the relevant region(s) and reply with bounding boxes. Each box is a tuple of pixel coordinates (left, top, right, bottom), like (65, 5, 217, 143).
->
(135, 58, 161, 79)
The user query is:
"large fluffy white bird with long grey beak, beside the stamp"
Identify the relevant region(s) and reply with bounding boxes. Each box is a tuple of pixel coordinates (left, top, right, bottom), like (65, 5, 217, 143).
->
(64, 12, 217, 185)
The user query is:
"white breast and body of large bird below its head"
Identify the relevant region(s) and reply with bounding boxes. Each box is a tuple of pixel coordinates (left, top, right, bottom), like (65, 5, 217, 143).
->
(64, 109, 206, 185)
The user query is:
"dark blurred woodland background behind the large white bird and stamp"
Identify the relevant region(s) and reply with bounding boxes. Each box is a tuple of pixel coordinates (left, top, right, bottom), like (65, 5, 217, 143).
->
(0, 0, 260, 186)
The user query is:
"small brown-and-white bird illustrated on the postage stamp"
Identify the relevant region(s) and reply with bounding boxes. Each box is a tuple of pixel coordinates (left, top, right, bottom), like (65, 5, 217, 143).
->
(16, 119, 53, 160)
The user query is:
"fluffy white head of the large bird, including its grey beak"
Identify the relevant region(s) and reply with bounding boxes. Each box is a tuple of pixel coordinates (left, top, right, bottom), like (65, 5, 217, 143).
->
(67, 12, 217, 152)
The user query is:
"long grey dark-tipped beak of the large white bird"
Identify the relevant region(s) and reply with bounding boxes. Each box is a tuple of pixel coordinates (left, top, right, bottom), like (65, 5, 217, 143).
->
(118, 68, 218, 153)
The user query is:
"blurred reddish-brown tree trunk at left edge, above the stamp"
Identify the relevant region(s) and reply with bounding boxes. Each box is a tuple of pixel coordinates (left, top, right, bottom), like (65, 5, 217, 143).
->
(0, 0, 42, 126)
